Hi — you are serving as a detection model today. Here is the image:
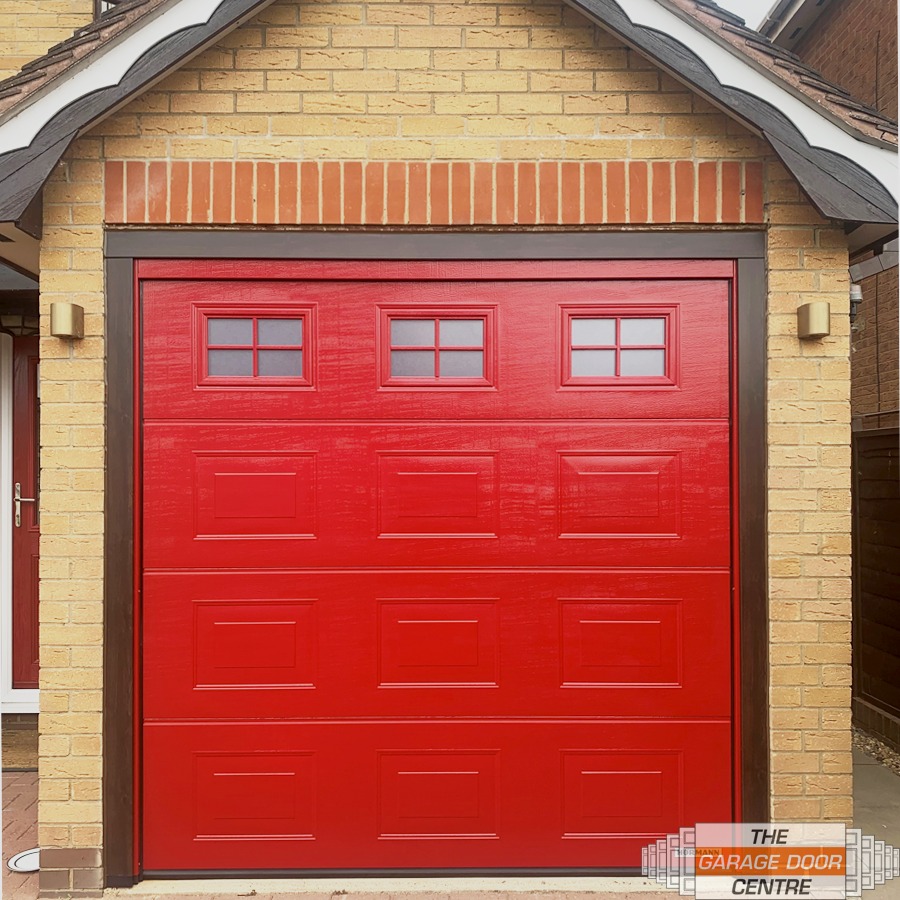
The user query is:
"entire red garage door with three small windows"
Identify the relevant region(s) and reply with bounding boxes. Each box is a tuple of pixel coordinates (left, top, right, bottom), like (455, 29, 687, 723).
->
(142, 263, 733, 871)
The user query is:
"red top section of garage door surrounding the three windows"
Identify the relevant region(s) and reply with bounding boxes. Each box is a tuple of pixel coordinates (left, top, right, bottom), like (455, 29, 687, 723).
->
(143, 279, 730, 422)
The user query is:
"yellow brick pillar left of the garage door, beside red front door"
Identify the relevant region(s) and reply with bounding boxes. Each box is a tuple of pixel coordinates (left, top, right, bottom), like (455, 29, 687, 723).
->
(39, 138, 105, 847)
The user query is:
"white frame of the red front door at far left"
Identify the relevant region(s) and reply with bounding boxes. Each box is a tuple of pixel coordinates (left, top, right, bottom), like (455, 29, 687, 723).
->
(0, 334, 38, 713)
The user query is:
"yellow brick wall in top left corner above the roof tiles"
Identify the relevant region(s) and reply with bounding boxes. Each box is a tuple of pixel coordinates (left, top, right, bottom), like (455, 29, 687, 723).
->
(0, 0, 94, 79)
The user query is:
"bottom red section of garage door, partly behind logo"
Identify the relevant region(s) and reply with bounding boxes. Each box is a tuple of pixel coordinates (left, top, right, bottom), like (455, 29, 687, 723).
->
(144, 719, 731, 871)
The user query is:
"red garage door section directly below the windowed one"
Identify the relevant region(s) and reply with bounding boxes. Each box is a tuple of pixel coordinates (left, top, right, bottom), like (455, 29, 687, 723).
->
(144, 421, 731, 568)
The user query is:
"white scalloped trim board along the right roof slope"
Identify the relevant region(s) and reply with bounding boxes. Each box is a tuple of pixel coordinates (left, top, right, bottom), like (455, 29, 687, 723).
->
(615, 0, 900, 200)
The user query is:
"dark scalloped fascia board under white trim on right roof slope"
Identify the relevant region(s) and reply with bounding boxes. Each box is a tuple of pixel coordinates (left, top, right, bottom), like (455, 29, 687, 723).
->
(565, 0, 898, 223)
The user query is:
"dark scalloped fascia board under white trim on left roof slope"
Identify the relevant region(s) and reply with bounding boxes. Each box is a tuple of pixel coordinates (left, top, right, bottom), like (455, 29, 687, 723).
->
(0, 0, 273, 222)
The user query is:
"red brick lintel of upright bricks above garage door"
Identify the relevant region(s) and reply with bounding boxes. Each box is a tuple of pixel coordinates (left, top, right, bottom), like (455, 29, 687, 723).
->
(106, 160, 763, 226)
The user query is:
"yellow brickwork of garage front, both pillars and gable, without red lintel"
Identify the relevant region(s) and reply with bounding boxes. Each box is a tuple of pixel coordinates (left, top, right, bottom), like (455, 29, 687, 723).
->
(40, 0, 851, 864)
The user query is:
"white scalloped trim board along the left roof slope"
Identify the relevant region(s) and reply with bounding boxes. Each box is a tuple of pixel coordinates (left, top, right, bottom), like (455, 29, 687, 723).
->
(0, 0, 232, 154)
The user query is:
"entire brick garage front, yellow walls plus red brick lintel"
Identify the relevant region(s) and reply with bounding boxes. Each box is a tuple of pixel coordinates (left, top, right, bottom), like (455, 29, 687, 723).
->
(28, 0, 852, 884)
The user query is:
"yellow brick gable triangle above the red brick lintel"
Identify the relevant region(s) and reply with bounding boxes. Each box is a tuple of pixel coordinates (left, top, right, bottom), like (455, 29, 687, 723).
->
(94, 0, 765, 160)
